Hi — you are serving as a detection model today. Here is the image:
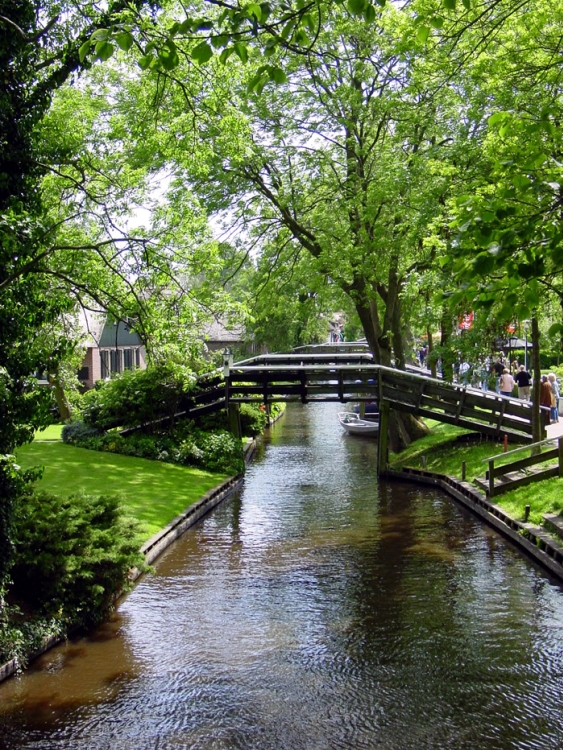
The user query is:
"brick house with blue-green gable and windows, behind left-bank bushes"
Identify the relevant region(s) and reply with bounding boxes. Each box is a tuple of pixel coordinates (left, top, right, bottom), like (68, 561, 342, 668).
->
(78, 309, 146, 389)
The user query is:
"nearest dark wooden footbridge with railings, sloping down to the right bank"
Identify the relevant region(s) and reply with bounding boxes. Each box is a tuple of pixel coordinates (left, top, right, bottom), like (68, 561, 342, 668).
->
(178, 352, 532, 450)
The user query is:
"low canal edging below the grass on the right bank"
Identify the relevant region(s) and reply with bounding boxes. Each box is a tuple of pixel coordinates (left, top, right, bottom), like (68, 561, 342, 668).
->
(381, 467, 563, 581)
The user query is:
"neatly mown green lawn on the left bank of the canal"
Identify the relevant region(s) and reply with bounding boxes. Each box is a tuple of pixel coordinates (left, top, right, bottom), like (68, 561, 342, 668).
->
(17, 440, 227, 538)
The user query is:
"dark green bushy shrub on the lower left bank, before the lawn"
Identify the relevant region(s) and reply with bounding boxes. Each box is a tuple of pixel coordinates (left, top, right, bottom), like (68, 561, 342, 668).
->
(10, 493, 146, 625)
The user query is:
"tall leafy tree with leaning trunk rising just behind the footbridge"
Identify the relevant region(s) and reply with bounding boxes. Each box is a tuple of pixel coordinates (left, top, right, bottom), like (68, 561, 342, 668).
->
(161, 4, 470, 447)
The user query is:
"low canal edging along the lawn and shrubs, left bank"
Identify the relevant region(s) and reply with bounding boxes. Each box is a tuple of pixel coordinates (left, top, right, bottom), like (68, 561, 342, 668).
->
(0, 440, 257, 682)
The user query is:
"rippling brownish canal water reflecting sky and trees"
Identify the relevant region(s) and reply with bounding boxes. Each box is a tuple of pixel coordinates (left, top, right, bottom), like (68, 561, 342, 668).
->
(0, 404, 563, 750)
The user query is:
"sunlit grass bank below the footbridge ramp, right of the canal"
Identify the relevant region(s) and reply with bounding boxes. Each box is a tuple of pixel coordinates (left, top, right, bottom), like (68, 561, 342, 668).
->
(390, 420, 563, 526)
